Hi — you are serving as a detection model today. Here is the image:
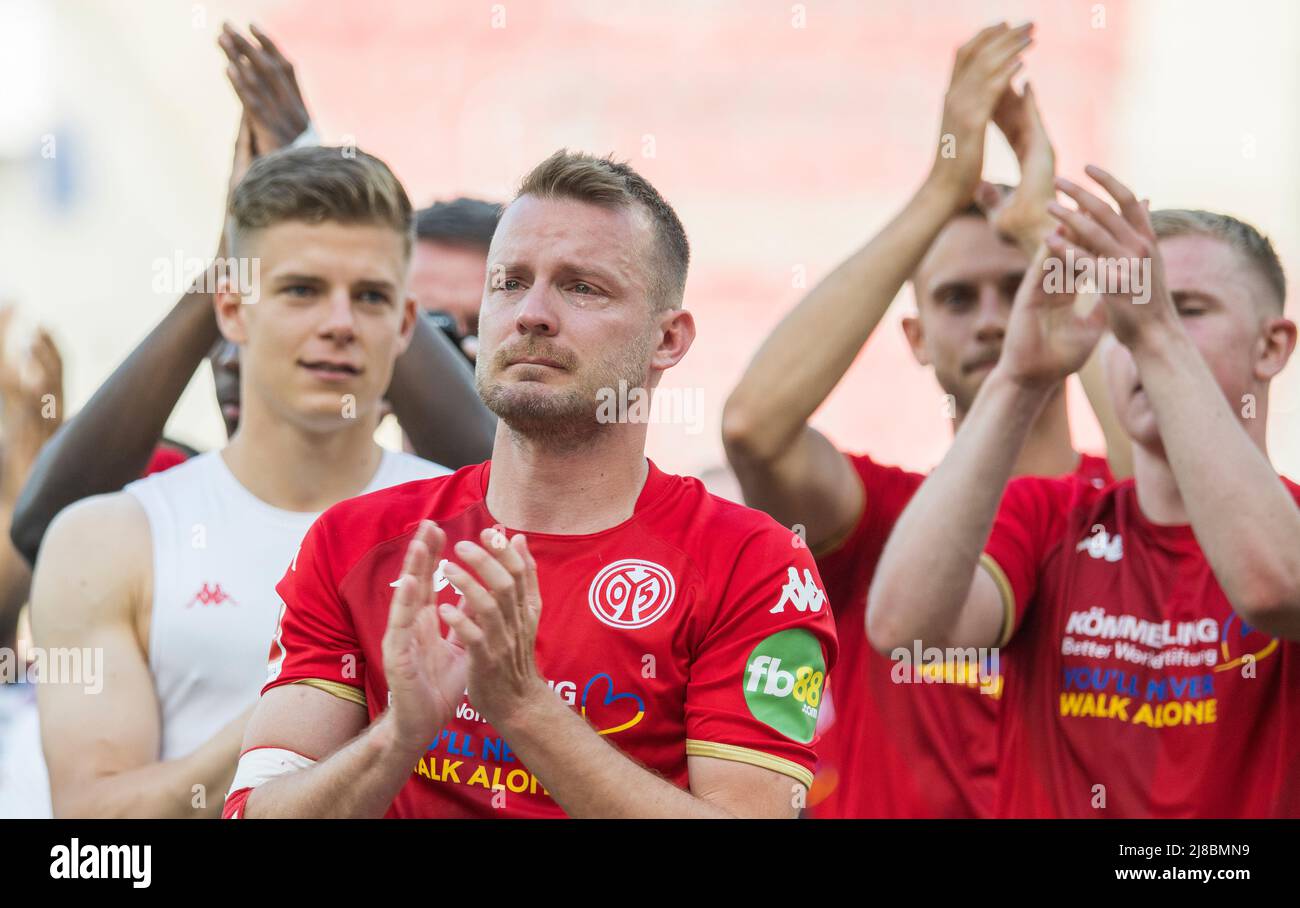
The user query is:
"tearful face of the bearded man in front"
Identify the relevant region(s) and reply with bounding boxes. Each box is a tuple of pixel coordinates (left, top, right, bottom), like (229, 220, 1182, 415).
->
(476, 195, 694, 440)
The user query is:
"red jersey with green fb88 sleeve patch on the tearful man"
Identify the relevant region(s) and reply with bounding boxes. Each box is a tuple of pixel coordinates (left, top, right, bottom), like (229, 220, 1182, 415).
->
(240, 462, 836, 817)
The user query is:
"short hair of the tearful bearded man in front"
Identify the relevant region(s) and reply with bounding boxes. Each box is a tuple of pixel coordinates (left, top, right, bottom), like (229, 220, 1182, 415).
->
(515, 148, 690, 310)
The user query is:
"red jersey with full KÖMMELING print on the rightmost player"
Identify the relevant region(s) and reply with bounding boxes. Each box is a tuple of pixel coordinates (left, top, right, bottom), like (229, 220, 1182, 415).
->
(984, 477, 1300, 817)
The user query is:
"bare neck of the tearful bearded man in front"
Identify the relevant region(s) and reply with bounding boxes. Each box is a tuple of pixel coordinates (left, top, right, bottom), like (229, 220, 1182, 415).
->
(488, 420, 650, 535)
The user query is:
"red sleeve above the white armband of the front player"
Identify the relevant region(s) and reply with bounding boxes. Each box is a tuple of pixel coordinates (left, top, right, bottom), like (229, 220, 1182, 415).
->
(263, 511, 365, 705)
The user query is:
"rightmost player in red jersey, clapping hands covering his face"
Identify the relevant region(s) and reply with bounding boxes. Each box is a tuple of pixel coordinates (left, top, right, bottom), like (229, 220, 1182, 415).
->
(868, 168, 1300, 817)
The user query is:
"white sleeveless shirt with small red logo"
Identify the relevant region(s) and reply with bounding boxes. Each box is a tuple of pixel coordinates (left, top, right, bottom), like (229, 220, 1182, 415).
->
(125, 451, 450, 760)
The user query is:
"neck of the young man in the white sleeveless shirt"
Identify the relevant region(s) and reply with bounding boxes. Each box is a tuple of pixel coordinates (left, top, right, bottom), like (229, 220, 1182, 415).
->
(221, 401, 384, 511)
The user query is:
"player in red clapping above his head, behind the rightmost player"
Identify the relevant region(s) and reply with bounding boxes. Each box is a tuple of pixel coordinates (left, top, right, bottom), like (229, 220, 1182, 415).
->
(723, 25, 1127, 818)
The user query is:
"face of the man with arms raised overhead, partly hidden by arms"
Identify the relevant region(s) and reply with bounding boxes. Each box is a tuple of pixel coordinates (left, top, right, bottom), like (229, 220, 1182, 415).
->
(902, 215, 1030, 415)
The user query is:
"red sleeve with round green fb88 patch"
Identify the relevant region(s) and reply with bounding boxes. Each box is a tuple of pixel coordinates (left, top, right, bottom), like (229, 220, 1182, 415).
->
(686, 526, 836, 786)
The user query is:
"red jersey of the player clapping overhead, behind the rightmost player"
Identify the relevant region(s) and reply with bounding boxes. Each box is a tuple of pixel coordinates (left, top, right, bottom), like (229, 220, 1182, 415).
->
(809, 454, 1113, 818)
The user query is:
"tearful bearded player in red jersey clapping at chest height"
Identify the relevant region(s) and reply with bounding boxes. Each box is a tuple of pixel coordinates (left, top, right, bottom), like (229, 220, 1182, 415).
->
(225, 146, 836, 817)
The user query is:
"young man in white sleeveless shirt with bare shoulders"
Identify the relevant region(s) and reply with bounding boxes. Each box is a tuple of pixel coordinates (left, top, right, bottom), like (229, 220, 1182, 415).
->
(33, 147, 446, 817)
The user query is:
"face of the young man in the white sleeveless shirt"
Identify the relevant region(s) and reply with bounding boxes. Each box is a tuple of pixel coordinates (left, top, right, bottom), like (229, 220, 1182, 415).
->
(217, 221, 416, 432)
